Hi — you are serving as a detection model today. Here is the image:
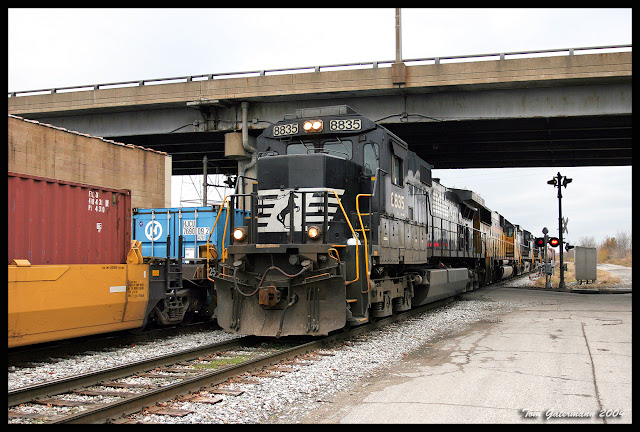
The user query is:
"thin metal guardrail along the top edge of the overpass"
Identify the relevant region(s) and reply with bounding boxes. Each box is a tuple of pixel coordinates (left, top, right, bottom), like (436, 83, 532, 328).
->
(8, 44, 632, 98)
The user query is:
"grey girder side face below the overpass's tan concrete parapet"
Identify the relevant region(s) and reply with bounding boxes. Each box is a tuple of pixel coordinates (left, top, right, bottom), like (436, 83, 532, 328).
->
(30, 82, 632, 137)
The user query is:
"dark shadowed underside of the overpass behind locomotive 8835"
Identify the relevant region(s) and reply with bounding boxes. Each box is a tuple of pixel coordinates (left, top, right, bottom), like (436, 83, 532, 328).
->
(106, 114, 632, 175)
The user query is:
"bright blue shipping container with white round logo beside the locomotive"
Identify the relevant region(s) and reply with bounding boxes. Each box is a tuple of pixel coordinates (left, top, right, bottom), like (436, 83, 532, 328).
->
(132, 206, 249, 260)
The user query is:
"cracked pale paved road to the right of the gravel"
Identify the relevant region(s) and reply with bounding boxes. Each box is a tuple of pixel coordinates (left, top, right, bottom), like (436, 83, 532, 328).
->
(304, 287, 632, 424)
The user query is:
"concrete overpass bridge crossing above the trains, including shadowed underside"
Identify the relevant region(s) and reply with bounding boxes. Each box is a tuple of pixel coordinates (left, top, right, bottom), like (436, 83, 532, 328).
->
(8, 45, 632, 175)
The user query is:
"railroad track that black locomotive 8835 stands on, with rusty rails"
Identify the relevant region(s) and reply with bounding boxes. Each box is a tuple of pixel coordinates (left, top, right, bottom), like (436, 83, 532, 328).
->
(8, 299, 460, 424)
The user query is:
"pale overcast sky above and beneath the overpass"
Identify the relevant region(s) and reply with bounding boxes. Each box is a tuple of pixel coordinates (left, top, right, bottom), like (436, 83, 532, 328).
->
(8, 8, 632, 242)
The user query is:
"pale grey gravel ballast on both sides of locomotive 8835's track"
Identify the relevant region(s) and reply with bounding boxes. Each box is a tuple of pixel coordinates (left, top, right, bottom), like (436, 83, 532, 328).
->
(9, 292, 536, 423)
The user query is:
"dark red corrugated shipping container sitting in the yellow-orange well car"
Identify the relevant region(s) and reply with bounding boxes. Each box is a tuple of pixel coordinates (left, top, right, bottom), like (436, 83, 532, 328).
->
(8, 172, 131, 265)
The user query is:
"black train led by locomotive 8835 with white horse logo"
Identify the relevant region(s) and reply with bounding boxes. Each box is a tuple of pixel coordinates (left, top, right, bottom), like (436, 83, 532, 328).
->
(213, 105, 535, 337)
